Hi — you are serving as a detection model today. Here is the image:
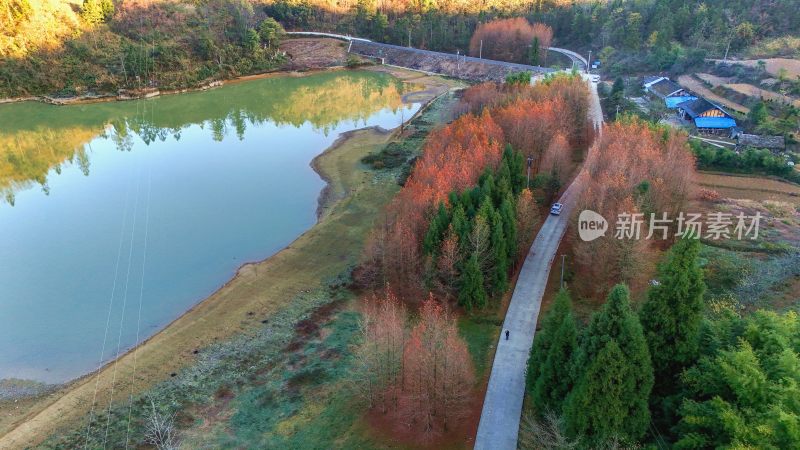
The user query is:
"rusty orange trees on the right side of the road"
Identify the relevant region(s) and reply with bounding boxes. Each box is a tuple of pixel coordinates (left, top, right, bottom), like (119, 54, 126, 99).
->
(575, 119, 695, 295)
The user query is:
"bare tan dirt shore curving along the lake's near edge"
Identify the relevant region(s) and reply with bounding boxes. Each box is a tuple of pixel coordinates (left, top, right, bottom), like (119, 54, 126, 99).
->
(0, 68, 452, 449)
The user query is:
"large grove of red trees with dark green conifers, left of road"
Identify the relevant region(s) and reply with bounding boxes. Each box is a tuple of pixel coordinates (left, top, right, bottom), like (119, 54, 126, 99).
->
(356, 75, 594, 298)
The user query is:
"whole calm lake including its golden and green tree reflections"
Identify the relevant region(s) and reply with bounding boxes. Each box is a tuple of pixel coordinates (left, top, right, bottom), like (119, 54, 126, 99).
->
(0, 71, 420, 383)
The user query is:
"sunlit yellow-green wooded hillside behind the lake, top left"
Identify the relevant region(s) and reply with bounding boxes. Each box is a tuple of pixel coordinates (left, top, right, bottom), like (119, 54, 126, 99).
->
(0, 0, 283, 97)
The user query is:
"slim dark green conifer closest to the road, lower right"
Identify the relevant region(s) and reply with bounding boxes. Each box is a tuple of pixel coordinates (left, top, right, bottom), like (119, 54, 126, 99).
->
(527, 289, 578, 414)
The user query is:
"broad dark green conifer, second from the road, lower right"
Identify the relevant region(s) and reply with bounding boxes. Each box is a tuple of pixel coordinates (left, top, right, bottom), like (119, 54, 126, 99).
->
(564, 284, 653, 442)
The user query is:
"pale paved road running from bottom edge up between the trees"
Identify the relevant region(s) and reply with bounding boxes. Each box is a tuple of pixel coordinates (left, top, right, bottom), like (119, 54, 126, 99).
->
(475, 77, 603, 450)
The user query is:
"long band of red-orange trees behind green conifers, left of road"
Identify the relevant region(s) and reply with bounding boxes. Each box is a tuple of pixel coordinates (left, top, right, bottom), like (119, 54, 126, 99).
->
(357, 75, 593, 298)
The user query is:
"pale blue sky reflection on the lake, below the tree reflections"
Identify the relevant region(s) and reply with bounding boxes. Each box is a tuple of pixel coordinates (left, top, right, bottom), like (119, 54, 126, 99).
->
(0, 71, 419, 382)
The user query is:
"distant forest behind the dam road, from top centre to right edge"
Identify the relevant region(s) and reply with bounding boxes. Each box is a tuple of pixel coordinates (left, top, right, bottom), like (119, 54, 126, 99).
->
(267, 0, 800, 70)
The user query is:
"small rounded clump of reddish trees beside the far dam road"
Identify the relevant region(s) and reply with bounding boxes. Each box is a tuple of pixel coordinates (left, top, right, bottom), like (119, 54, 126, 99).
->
(469, 17, 553, 64)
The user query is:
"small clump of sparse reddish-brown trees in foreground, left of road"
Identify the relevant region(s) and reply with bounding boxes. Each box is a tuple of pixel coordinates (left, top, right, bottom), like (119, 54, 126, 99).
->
(357, 288, 475, 434)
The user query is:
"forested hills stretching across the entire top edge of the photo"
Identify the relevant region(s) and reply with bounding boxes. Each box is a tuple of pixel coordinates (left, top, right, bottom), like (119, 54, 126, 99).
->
(0, 0, 800, 97)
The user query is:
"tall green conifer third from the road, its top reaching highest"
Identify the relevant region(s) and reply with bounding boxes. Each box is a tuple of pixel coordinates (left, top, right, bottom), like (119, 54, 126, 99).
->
(639, 238, 706, 431)
